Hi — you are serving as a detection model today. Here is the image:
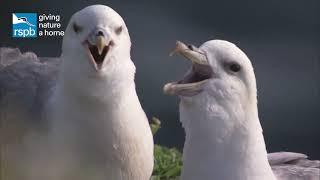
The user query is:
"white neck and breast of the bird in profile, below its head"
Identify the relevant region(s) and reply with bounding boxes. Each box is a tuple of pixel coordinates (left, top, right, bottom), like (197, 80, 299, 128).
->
(180, 99, 275, 180)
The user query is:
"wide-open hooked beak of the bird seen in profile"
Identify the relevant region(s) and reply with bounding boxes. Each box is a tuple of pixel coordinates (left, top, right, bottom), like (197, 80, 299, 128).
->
(163, 41, 213, 96)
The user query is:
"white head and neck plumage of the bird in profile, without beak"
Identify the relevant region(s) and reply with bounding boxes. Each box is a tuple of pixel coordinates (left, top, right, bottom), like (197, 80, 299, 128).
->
(180, 40, 275, 180)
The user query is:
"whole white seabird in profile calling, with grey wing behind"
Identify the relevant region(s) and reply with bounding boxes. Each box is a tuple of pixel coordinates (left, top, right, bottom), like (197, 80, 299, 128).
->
(164, 40, 320, 180)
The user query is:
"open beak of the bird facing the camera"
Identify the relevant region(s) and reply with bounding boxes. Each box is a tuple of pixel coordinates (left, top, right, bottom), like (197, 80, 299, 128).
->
(83, 35, 111, 71)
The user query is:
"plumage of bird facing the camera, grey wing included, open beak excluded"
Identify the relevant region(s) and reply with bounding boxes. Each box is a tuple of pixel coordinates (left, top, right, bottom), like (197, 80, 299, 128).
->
(0, 5, 153, 180)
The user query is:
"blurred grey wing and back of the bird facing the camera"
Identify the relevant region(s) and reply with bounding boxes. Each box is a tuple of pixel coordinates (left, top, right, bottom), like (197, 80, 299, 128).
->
(0, 47, 60, 143)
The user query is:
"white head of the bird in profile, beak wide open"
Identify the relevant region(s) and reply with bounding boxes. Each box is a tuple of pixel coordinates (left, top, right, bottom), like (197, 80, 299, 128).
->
(164, 40, 256, 109)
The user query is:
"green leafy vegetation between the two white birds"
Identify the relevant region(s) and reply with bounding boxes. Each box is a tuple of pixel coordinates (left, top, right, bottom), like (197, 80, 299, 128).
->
(150, 117, 182, 180)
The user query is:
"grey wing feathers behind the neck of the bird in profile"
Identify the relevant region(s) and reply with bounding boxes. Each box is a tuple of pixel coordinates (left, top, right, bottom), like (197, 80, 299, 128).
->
(268, 152, 320, 180)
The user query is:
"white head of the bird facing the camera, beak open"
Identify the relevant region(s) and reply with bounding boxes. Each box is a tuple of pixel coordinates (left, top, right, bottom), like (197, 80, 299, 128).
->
(62, 5, 131, 75)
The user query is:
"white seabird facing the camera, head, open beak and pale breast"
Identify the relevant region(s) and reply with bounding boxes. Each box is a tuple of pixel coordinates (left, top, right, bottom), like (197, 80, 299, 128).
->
(1, 5, 153, 180)
